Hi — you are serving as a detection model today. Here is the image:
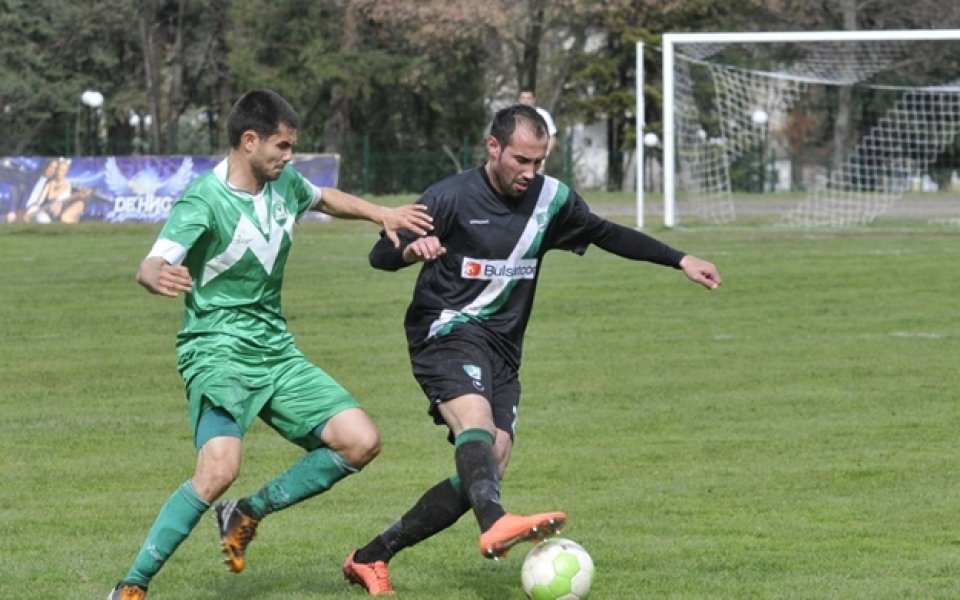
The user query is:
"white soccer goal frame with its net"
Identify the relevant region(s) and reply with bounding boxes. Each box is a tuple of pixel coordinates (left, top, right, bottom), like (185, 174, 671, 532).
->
(635, 29, 960, 228)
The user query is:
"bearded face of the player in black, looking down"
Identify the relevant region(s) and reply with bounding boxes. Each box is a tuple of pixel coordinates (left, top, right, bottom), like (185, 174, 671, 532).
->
(487, 123, 549, 198)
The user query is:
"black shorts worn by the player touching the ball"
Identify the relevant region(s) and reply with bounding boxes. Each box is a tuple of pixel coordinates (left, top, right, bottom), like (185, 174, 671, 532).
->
(410, 332, 520, 440)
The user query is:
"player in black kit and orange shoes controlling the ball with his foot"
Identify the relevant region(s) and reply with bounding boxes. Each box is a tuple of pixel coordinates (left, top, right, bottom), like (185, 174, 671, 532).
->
(343, 105, 721, 596)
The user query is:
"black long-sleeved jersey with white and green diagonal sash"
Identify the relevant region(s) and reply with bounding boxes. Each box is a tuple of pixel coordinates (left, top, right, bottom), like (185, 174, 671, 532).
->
(370, 167, 683, 368)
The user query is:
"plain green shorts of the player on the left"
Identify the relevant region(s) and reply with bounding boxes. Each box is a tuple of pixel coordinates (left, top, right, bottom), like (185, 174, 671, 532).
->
(177, 336, 360, 450)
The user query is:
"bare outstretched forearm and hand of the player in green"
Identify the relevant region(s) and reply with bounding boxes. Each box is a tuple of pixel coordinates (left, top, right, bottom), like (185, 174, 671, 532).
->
(317, 188, 433, 248)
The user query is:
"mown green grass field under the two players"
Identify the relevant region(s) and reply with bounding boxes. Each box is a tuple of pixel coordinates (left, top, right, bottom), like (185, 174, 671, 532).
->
(0, 200, 960, 600)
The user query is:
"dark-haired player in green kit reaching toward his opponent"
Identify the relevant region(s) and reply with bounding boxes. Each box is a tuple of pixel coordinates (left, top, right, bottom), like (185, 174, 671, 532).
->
(107, 90, 432, 600)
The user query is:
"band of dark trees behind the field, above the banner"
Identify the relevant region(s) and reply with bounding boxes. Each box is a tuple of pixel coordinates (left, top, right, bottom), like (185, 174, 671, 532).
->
(0, 0, 960, 193)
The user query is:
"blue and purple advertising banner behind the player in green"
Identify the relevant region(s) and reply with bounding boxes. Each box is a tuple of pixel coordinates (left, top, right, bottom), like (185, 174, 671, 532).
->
(0, 154, 340, 223)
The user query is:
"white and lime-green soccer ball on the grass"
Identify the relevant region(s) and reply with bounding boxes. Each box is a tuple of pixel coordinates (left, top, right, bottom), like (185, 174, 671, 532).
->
(520, 537, 593, 600)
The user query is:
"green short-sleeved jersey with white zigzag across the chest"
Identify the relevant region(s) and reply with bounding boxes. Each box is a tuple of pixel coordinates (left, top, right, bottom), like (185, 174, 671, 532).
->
(150, 159, 320, 349)
